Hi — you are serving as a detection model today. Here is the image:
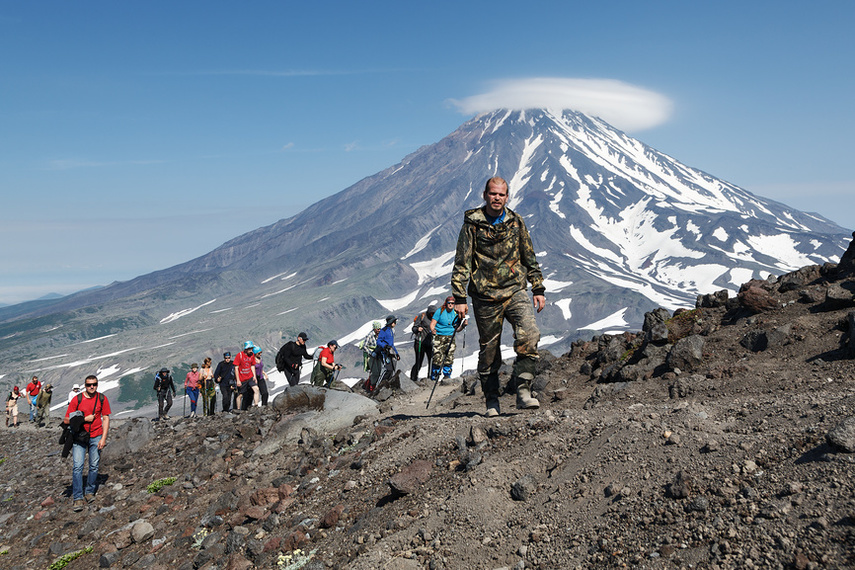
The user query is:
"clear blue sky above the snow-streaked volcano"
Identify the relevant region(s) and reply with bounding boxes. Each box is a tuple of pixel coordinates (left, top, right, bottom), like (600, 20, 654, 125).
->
(0, 0, 855, 303)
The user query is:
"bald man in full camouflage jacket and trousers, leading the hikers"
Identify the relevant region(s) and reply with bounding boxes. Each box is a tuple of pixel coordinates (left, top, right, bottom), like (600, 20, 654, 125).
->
(451, 177, 546, 416)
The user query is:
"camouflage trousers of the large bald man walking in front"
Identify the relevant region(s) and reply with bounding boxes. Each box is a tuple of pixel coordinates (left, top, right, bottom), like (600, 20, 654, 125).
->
(472, 290, 540, 398)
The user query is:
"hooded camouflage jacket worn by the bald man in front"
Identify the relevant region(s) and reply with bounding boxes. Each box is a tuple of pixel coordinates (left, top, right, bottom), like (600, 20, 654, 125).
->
(451, 207, 545, 303)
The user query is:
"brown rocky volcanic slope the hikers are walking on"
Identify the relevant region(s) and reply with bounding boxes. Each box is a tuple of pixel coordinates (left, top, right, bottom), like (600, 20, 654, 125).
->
(0, 236, 855, 570)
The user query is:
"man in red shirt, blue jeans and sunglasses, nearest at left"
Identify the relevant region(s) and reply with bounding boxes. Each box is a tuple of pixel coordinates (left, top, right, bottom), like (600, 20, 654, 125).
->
(63, 375, 110, 512)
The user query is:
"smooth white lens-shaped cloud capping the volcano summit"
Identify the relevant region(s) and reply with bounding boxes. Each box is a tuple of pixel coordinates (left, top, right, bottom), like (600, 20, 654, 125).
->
(451, 77, 673, 131)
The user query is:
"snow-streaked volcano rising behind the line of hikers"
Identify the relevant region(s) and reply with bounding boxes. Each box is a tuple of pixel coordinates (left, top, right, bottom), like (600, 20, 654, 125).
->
(0, 110, 849, 404)
